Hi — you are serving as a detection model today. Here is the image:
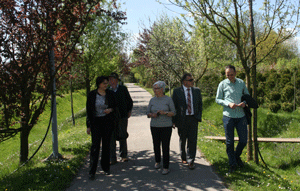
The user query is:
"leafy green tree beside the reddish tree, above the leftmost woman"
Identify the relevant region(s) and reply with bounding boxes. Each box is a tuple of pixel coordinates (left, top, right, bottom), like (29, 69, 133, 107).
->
(78, 12, 126, 94)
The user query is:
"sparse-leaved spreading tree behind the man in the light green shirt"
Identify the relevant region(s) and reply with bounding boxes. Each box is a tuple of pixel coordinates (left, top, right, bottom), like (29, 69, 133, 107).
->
(170, 0, 299, 160)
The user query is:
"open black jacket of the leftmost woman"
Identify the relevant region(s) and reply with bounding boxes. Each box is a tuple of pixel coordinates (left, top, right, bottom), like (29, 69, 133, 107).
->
(86, 89, 117, 128)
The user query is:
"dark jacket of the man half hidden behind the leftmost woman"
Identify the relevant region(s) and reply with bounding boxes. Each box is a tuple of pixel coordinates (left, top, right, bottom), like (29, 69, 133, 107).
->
(113, 85, 133, 118)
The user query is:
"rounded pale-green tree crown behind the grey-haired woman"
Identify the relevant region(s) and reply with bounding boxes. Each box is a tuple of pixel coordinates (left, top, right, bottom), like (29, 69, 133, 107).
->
(136, 15, 218, 88)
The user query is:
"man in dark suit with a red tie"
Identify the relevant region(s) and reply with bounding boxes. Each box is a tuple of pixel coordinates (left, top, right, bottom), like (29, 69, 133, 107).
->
(172, 73, 202, 169)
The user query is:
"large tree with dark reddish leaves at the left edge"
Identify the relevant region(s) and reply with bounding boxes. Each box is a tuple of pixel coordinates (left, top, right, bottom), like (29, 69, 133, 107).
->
(0, 0, 119, 162)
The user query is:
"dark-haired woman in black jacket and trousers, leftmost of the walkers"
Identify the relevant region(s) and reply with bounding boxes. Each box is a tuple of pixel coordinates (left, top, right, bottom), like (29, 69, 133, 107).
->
(86, 76, 117, 179)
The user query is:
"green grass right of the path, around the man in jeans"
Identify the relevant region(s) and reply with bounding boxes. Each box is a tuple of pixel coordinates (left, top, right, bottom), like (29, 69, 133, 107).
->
(198, 98, 300, 190)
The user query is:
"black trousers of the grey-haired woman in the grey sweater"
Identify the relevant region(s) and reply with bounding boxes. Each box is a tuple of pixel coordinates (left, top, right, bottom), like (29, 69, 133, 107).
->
(151, 127, 172, 169)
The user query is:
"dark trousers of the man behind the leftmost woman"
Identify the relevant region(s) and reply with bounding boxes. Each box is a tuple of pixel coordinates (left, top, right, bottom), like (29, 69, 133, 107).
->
(110, 118, 128, 162)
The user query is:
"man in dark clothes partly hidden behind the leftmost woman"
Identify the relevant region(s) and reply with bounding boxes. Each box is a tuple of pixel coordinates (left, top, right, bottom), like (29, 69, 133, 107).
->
(109, 72, 133, 164)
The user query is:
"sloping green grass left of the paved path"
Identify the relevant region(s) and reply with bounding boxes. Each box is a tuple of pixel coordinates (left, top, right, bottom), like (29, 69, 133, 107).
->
(0, 91, 90, 190)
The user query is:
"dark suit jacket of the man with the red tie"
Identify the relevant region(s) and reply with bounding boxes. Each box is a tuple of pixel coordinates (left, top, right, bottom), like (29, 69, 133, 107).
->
(172, 86, 202, 128)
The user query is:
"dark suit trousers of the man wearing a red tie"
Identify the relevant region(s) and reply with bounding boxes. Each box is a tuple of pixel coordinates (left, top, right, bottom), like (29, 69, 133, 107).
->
(178, 115, 198, 163)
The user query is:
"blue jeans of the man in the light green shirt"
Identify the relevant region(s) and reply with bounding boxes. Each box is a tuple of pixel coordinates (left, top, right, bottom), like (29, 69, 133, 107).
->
(223, 116, 248, 166)
